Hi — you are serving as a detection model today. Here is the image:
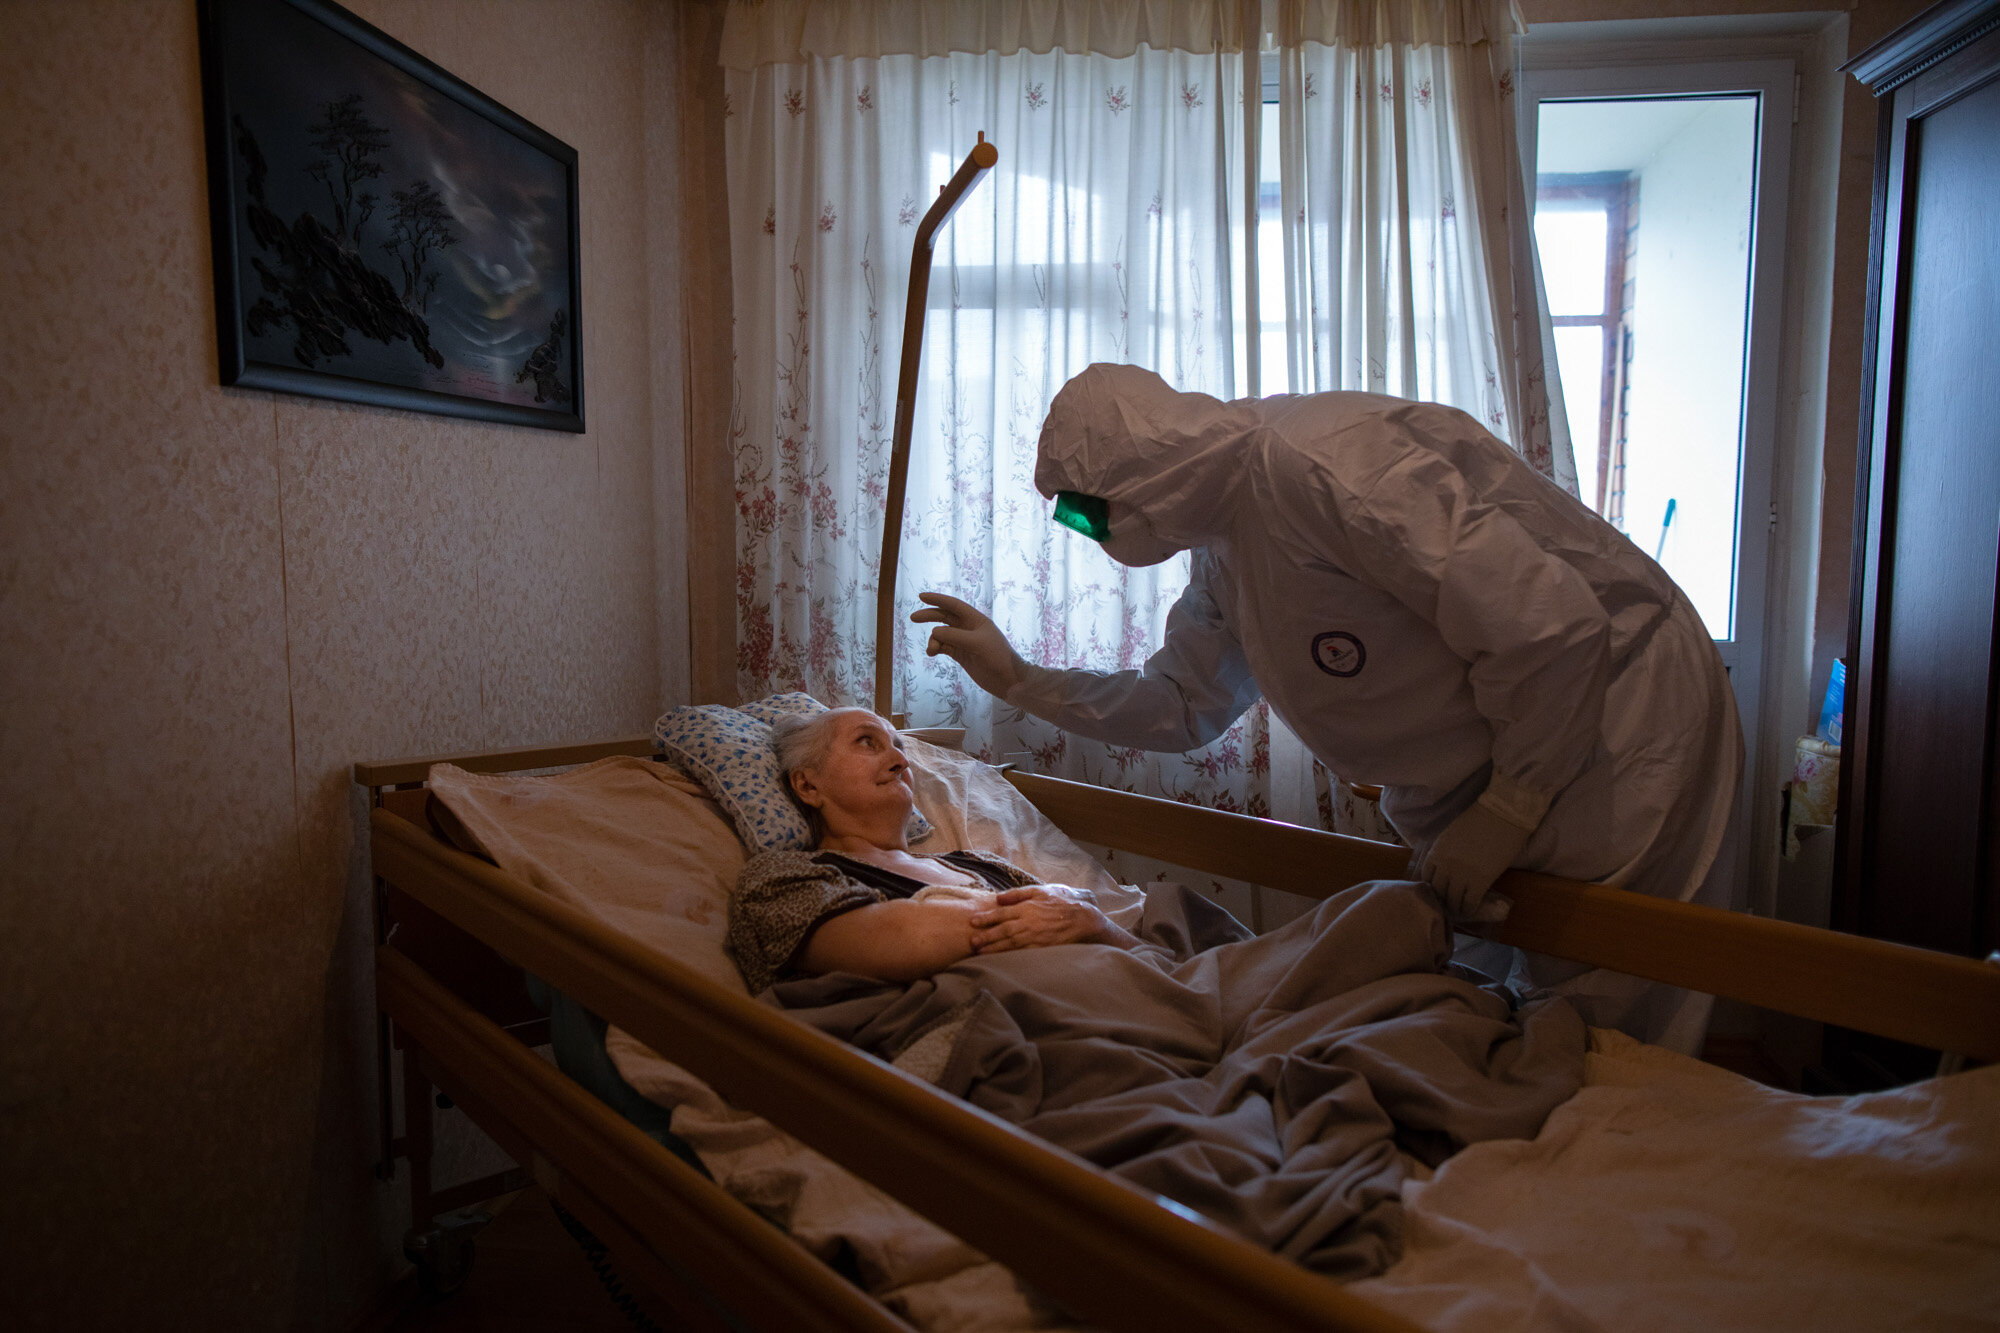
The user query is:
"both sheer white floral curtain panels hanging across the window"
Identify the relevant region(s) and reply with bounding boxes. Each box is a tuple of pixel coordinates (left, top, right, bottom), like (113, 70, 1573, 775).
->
(724, 0, 1574, 880)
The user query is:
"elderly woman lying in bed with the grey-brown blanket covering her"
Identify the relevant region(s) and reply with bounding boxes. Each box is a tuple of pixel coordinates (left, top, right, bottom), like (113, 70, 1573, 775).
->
(730, 709, 1584, 1277)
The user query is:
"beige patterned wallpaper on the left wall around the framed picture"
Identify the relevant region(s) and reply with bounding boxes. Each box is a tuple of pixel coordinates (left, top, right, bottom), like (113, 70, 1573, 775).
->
(0, 0, 686, 1329)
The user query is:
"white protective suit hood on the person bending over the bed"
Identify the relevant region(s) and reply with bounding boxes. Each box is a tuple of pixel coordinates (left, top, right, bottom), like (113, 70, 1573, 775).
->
(1034, 364, 1262, 564)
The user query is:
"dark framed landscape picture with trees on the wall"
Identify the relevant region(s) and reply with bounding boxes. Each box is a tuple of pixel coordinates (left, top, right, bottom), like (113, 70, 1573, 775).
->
(200, 0, 584, 430)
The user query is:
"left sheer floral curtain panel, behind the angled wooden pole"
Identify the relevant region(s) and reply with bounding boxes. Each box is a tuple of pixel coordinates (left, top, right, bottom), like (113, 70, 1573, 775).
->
(724, 15, 1268, 813)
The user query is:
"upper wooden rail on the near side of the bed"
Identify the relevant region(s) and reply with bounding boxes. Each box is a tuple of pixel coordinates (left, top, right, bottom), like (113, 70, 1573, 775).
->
(372, 809, 1416, 1333)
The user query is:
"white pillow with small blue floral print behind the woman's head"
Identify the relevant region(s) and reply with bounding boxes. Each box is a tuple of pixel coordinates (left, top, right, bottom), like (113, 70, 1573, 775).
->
(652, 691, 932, 857)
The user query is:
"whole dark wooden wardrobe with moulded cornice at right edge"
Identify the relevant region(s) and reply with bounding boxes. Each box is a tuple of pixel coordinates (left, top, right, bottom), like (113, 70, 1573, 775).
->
(1830, 0, 2000, 1073)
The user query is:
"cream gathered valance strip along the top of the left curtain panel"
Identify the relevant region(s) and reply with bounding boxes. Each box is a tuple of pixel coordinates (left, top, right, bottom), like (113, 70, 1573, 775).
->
(722, 0, 1242, 70)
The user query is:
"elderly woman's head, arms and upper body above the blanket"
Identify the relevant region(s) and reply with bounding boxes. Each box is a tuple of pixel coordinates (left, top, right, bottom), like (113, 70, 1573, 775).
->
(730, 709, 1138, 991)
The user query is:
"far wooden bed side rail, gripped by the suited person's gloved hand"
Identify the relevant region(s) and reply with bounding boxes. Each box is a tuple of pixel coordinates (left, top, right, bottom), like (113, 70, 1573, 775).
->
(1008, 773, 2000, 1061)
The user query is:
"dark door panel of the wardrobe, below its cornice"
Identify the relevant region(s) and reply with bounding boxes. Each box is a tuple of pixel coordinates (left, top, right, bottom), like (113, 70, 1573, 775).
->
(1858, 72, 2000, 953)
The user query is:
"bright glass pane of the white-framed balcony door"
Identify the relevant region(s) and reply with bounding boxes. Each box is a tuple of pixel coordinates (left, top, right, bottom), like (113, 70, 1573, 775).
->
(1534, 94, 1758, 638)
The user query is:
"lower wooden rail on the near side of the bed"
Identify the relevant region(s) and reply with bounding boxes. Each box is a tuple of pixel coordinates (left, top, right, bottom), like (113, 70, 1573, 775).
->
(376, 945, 908, 1333)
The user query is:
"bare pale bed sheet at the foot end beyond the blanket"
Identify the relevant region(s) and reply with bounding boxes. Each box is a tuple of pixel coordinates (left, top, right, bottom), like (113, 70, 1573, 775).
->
(1354, 1029, 2000, 1333)
